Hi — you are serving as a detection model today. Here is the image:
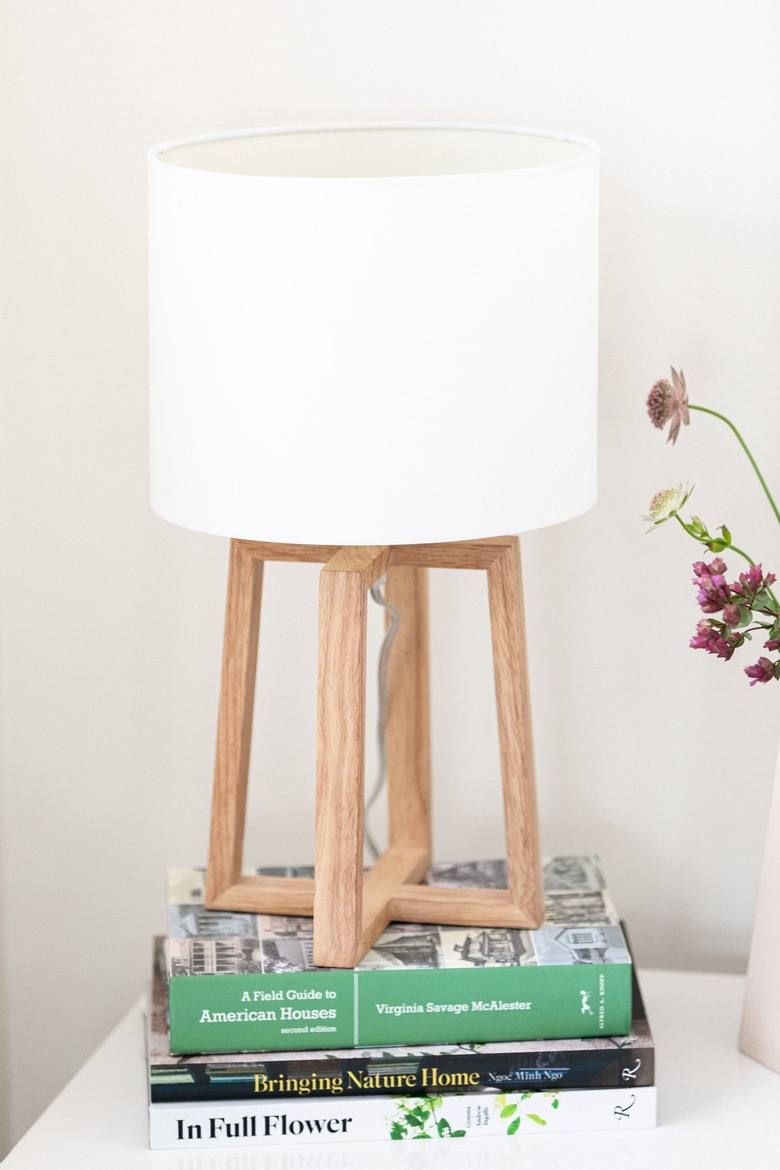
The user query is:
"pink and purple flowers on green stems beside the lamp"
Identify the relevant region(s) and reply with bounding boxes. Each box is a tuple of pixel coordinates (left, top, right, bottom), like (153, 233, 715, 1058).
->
(643, 367, 780, 687)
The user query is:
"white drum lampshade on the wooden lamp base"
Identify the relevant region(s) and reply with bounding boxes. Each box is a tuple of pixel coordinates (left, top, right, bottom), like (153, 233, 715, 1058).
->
(150, 125, 598, 544)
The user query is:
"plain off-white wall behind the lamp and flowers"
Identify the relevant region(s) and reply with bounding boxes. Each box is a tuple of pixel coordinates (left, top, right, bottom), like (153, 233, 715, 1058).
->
(0, 0, 780, 1148)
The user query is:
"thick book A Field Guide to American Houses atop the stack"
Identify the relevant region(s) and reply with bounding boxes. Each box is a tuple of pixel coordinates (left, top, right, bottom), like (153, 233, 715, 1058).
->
(167, 856, 631, 1053)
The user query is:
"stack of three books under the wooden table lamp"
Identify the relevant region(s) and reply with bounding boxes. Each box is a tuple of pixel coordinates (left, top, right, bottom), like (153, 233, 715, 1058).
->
(149, 856, 656, 1149)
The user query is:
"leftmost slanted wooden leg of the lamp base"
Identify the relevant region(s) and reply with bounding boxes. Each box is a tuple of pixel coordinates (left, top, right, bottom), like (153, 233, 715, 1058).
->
(206, 541, 263, 906)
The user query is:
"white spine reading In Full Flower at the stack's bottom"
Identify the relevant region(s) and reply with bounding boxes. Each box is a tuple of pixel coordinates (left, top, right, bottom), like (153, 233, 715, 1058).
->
(150, 1086, 656, 1149)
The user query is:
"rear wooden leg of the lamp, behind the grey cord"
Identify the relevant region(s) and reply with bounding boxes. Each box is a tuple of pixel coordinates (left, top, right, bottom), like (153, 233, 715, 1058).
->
(386, 565, 430, 861)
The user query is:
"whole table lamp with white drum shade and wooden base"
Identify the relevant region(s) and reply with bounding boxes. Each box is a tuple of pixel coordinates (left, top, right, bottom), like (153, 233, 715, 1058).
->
(150, 124, 598, 966)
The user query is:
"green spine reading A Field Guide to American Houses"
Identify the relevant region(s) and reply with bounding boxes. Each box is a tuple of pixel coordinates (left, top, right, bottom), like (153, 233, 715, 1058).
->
(170, 962, 631, 1053)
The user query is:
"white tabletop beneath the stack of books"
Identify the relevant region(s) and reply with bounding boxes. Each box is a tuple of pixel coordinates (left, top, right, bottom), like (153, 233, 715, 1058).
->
(4, 971, 780, 1170)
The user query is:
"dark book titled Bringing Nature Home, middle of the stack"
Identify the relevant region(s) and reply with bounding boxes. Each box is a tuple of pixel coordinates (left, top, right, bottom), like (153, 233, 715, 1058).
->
(149, 938, 655, 1103)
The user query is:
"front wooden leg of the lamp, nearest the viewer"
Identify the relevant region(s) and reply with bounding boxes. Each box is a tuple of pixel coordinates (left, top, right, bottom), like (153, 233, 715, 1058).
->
(313, 548, 388, 966)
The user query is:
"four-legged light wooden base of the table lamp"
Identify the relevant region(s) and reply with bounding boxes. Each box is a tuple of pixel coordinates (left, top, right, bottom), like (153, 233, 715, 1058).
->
(206, 537, 543, 968)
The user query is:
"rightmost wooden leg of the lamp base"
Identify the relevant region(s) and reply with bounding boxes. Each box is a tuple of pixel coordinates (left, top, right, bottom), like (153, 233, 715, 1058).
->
(488, 538, 544, 927)
